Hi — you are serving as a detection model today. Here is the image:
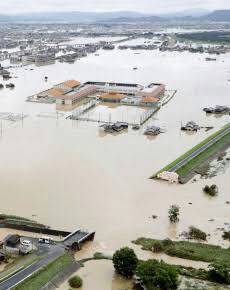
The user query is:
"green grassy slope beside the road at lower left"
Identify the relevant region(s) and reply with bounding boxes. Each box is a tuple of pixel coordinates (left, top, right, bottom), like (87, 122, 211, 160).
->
(13, 253, 73, 290)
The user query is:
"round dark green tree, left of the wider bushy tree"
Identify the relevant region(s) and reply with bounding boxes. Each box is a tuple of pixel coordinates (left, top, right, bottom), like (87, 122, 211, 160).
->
(113, 247, 138, 278)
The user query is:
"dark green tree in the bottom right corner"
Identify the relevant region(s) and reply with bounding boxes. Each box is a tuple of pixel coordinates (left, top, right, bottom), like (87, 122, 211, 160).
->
(208, 263, 230, 284)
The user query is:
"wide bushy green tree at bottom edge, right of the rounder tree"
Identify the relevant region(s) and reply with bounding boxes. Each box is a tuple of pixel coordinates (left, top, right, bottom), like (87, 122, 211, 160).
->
(136, 260, 178, 290)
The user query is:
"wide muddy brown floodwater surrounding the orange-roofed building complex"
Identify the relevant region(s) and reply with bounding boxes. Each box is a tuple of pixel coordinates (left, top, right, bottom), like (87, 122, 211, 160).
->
(0, 38, 230, 280)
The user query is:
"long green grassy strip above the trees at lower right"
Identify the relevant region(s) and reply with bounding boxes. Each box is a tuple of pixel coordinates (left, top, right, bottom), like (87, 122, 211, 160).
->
(133, 238, 230, 263)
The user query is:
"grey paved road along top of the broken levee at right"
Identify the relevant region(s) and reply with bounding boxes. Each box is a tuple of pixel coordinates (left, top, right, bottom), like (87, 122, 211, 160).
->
(169, 127, 230, 172)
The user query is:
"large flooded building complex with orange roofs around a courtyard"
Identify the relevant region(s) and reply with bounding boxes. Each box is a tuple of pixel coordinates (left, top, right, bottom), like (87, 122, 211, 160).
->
(31, 80, 165, 107)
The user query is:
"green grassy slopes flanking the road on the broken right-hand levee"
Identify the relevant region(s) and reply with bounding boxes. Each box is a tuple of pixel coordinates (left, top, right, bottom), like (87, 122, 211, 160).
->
(151, 124, 230, 178)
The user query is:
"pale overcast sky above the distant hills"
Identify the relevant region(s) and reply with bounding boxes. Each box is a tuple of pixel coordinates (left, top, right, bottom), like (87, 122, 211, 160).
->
(0, 0, 230, 14)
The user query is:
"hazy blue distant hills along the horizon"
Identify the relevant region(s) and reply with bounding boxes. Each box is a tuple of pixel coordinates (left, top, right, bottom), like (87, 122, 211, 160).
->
(0, 9, 230, 23)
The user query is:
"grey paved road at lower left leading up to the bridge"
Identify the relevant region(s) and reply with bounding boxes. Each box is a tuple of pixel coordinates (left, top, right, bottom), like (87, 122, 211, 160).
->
(0, 245, 64, 290)
